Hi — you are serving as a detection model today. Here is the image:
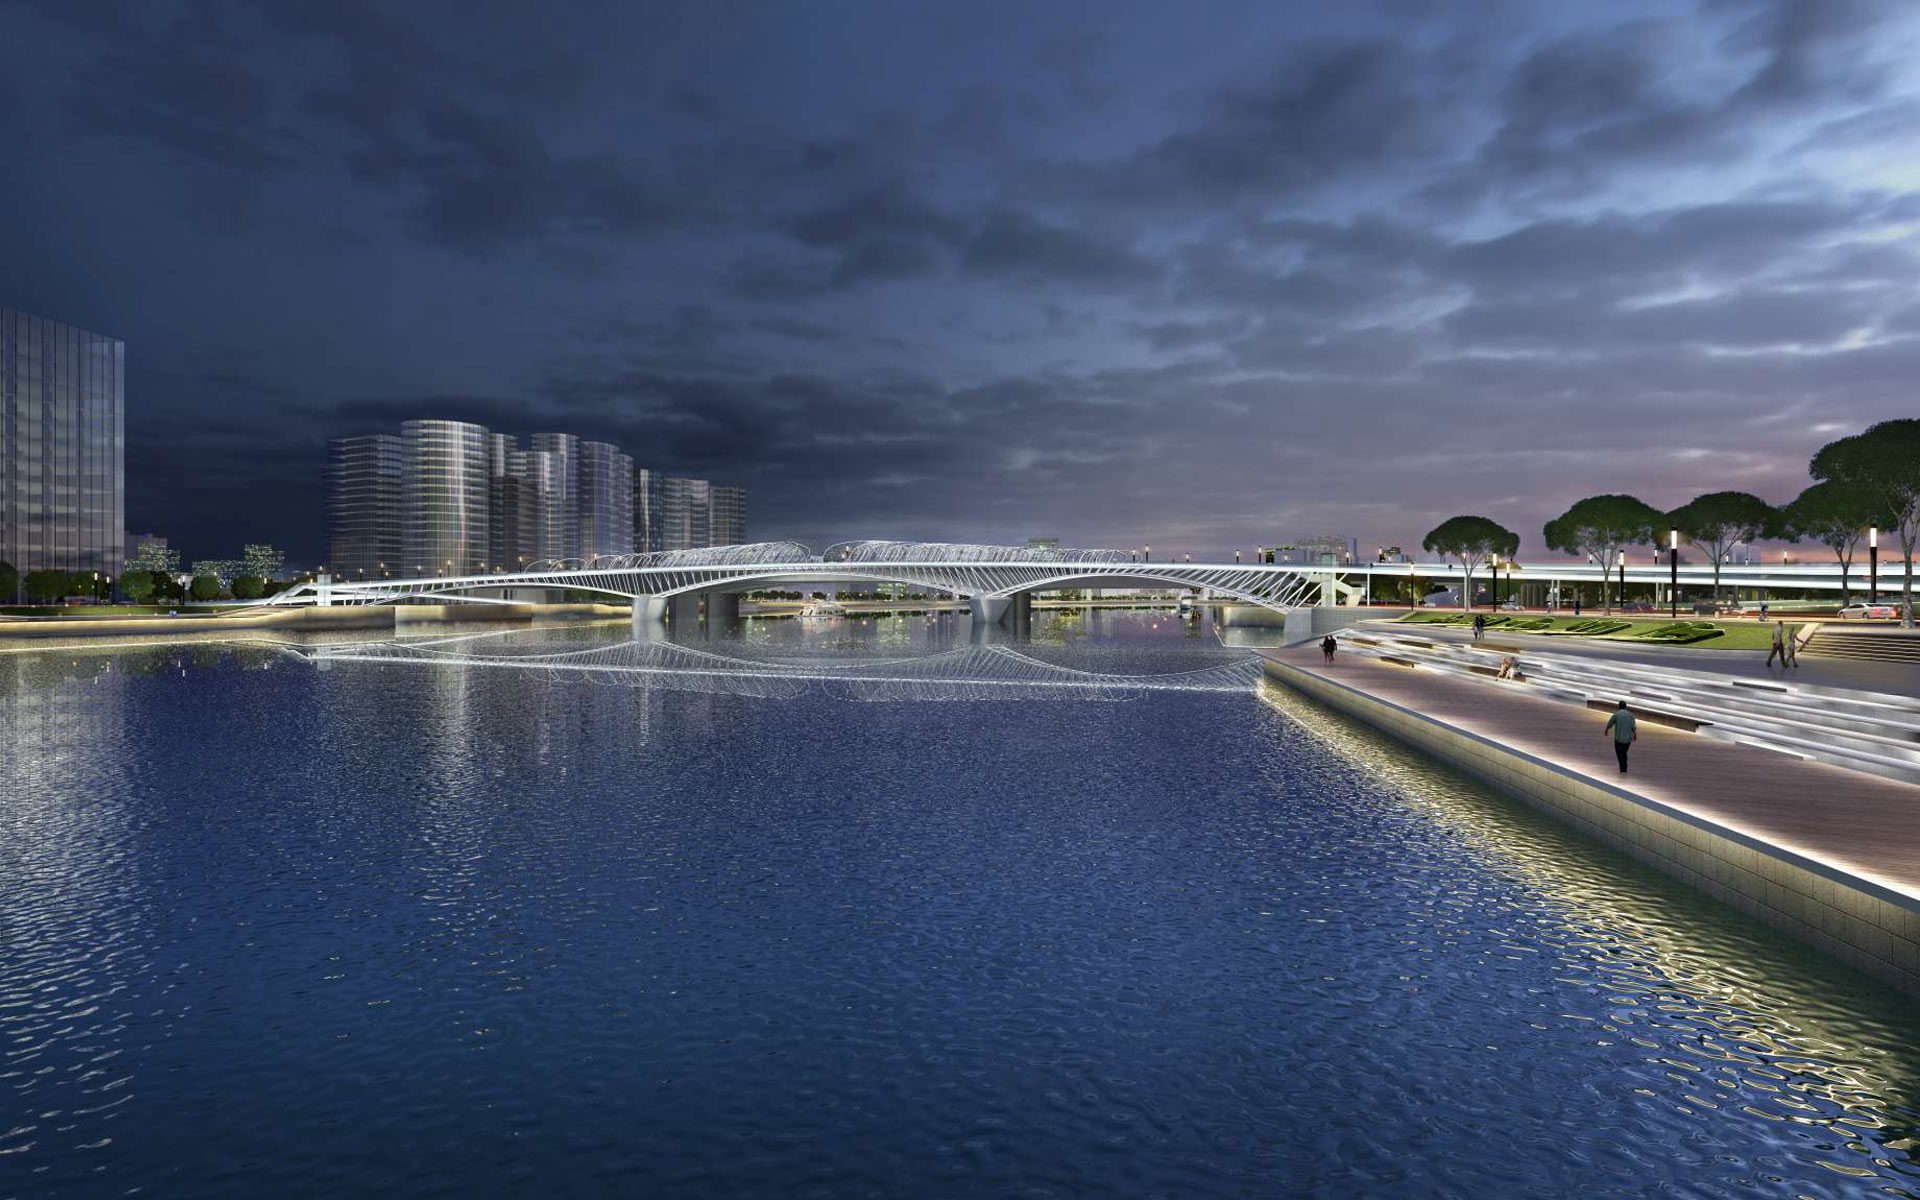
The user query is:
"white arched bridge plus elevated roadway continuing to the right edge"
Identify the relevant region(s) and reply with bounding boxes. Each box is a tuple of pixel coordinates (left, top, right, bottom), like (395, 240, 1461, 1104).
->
(259, 541, 1903, 624)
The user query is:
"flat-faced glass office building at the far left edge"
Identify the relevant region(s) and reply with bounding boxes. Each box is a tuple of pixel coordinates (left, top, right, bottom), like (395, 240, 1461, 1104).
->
(0, 309, 127, 579)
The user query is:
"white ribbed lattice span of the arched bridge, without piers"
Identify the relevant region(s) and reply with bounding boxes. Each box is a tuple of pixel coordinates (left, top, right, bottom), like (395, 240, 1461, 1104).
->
(259, 541, 1354, 611)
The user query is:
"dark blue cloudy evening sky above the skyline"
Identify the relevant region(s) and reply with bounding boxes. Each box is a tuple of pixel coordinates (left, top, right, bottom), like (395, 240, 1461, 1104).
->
(0, 0, 1920, 563)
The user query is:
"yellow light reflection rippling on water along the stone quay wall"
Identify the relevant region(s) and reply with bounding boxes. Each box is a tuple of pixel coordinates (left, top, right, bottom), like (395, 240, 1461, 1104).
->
(1260, 684, 1920, 1194)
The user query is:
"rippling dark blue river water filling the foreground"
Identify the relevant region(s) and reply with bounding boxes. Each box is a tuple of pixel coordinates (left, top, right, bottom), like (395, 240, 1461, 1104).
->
(0, 612, 1920, 1196)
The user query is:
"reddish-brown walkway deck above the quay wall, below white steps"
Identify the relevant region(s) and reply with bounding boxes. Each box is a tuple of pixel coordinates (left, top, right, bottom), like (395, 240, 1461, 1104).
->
(1263, 645, 1920, 899)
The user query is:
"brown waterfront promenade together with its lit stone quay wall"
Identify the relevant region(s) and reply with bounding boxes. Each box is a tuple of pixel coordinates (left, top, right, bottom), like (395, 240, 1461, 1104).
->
(1263, 645, 1920, 995)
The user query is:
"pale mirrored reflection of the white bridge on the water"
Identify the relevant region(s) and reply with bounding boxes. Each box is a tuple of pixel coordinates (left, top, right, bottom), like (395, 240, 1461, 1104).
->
(294, 634, 1260, 701)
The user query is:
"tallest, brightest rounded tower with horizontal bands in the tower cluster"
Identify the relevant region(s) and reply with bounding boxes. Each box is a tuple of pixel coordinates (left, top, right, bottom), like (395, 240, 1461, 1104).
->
(399, 420, 492, 576)
